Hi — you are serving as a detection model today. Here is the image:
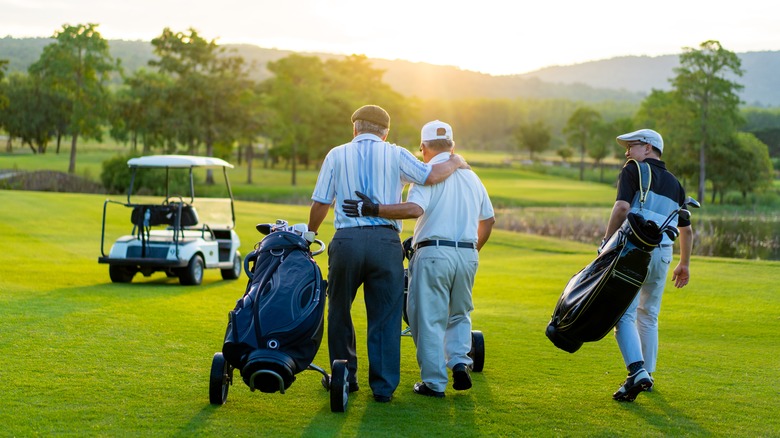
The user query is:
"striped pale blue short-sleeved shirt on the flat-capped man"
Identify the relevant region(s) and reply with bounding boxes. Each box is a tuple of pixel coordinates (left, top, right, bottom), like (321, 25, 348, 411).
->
(311, 134, 432, 231)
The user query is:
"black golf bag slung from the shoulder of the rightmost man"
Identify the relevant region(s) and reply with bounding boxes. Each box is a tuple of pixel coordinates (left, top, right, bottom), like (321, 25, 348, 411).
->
(545, 163, 699, 353)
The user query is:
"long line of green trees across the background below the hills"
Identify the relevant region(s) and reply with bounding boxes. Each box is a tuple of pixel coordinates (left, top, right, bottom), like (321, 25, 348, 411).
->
(0, 24, 780, 204)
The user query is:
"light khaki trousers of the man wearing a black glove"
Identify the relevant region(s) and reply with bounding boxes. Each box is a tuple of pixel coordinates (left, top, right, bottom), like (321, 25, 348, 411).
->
(406, 246, 479, 391)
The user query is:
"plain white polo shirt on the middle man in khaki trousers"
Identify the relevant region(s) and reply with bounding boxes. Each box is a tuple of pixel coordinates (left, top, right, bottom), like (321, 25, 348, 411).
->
(406, 152, 494, 245)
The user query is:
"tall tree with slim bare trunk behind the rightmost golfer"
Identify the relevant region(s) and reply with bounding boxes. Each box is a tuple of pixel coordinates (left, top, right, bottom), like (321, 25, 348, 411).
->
(671, 40, 743, 199)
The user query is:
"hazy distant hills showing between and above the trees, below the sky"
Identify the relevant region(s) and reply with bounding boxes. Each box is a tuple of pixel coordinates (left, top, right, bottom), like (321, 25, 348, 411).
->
(0, 37, 780, 107)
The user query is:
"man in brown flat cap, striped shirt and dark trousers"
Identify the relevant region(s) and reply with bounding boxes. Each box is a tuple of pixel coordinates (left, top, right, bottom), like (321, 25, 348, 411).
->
(308, 105, 468, 403)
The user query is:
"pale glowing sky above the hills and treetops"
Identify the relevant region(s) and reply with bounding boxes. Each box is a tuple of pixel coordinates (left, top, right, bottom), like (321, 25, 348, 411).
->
(0, 0, 780, 75)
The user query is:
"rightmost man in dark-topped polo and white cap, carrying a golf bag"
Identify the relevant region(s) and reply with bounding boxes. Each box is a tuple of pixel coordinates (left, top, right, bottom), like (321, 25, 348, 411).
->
(602, 129, 693, 401)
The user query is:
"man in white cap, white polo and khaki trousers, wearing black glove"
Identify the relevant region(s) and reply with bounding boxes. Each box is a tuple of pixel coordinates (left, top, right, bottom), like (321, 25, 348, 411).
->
(343, 120, 495, 398)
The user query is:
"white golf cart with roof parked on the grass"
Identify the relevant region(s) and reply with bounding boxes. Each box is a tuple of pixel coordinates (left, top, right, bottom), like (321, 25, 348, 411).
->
(98, 155, 242, 285)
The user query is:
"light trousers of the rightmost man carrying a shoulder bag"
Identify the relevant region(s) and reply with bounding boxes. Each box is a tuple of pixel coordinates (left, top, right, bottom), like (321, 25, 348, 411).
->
(615, 246, 673, 373)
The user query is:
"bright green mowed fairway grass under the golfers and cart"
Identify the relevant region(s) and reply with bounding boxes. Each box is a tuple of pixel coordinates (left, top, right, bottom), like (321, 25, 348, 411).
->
(0, 191, 780, 437)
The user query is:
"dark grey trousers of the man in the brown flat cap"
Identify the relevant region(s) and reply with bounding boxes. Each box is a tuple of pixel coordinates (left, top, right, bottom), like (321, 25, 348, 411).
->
(328, 227, 404, 396)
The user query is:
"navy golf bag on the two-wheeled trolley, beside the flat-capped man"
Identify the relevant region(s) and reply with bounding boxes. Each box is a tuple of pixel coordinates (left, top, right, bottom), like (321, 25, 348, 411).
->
(222, 229, 326, 393)
